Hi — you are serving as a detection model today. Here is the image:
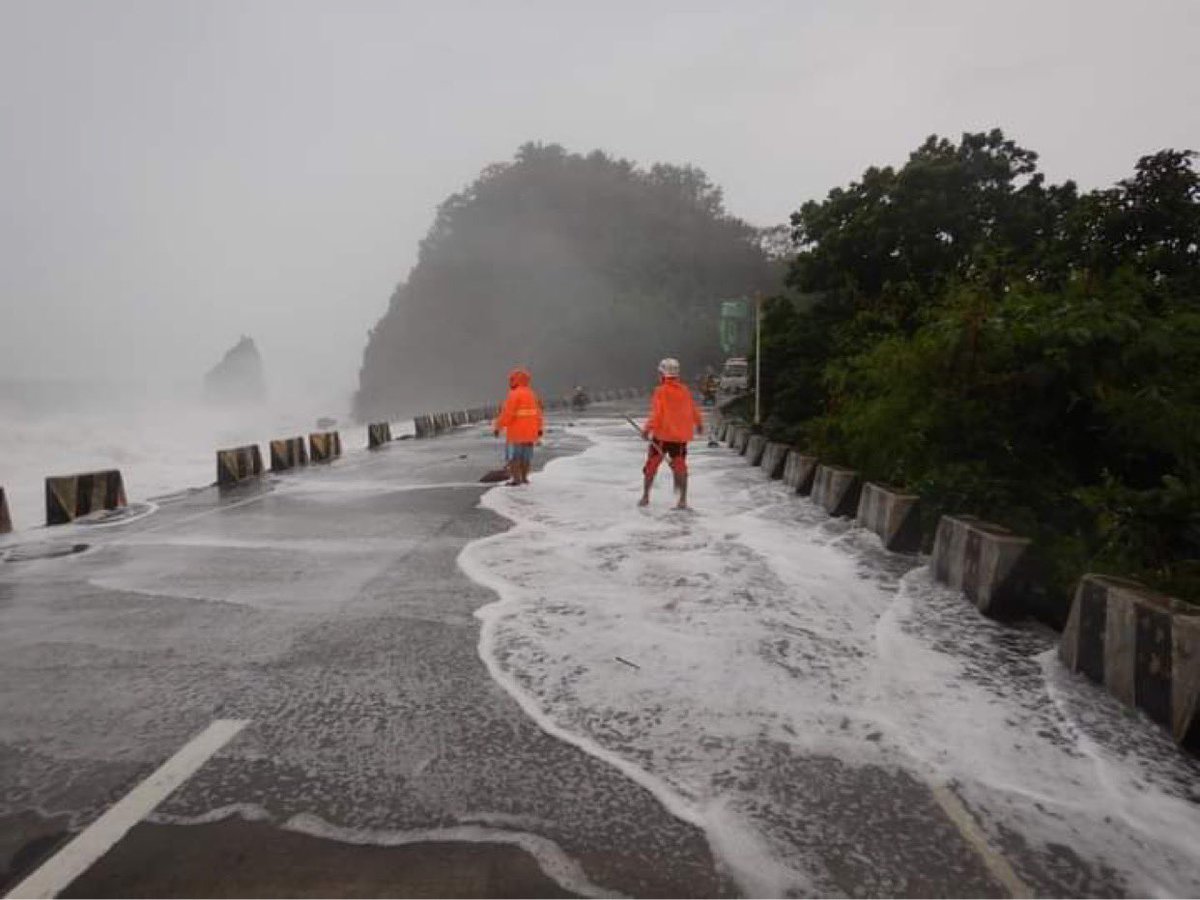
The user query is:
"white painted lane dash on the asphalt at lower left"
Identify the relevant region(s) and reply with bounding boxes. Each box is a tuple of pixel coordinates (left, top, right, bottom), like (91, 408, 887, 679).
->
(8, 719, 248, 898)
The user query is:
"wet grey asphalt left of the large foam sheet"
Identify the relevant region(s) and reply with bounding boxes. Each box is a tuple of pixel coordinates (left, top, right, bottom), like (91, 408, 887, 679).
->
(0, 410, 733, 896)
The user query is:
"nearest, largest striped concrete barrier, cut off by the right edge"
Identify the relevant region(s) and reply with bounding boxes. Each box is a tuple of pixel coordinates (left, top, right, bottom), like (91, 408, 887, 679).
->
(1058, 575, 1200, 752)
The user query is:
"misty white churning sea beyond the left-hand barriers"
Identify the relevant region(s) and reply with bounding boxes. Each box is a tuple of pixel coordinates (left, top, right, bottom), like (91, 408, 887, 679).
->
(0, 379, 354, 532)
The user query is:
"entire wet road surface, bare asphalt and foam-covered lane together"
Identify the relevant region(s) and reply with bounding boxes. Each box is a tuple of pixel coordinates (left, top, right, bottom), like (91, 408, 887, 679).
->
(0, 402, 1193, 896)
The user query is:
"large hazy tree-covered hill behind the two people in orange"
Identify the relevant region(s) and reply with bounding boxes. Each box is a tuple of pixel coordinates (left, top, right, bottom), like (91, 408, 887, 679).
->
(356, 144, 781, 416)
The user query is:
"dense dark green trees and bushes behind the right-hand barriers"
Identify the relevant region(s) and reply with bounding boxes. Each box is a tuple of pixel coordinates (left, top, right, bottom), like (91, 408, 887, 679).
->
(762, 131, 1200, 614)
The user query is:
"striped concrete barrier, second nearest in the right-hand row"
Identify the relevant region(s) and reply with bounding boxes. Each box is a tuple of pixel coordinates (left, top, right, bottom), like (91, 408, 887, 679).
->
(930, 516, 1030, 618)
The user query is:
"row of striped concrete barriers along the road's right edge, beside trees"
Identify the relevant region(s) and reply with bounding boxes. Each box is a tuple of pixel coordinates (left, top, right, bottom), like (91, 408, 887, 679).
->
(716, 420, 1200, 754)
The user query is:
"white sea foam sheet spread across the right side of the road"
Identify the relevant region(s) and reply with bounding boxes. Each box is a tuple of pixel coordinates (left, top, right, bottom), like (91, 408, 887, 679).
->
(460, 425, 1200, 895)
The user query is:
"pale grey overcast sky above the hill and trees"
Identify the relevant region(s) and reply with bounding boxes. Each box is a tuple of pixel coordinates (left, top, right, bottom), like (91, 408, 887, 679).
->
(0, 0, 1200, 388)
